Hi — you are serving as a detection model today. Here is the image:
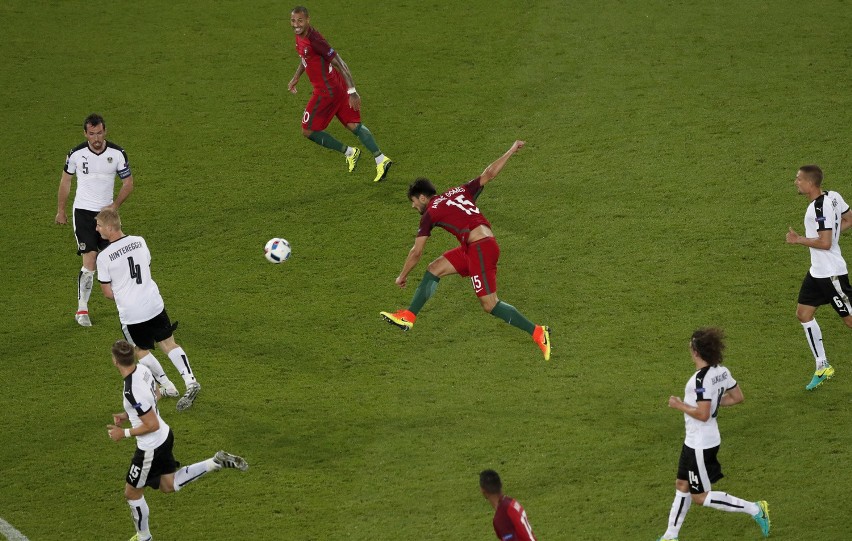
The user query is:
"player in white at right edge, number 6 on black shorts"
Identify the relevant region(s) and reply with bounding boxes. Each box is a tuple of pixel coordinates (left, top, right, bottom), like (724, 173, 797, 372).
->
(787, 165, 852, 391)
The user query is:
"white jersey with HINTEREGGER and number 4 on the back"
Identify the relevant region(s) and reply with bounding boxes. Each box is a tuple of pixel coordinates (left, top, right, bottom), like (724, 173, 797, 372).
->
(98, 235, 165, 325)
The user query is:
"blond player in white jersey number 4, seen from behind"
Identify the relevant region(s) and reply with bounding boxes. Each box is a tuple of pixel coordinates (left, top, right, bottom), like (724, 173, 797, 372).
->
(96, 209, 201, 411)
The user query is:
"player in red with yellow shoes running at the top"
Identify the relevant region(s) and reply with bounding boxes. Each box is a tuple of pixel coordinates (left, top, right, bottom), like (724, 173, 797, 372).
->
(287, 6, 393, 182)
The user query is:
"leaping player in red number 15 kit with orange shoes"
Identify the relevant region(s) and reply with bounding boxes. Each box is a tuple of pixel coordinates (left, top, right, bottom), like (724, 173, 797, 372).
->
(381, 141, 550, 361)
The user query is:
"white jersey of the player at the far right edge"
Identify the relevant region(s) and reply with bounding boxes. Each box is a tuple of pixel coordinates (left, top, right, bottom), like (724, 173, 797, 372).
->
(805, 191, 849, 278)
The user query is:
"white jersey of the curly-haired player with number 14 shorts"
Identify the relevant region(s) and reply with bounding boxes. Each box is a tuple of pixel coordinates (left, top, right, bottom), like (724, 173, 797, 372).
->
(683, 365, 737, 449)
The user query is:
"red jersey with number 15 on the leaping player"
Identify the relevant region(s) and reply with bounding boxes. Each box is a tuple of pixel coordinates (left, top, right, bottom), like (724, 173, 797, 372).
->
(417, 177, 491, 246)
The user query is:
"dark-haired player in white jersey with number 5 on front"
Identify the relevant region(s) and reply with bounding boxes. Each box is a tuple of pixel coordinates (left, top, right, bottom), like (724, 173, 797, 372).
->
(55, 114, 133, 327)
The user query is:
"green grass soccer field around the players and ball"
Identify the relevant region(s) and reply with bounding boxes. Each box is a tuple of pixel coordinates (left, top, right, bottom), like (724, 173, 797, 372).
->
(0, 0, 852, 541)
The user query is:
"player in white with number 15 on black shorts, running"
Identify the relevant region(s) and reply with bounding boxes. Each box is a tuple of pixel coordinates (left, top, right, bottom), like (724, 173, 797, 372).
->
(107, 340, 248, 541)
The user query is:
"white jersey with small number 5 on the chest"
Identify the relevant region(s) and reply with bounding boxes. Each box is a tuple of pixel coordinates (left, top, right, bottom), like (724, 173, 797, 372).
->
(65, 141, 131, 212)
